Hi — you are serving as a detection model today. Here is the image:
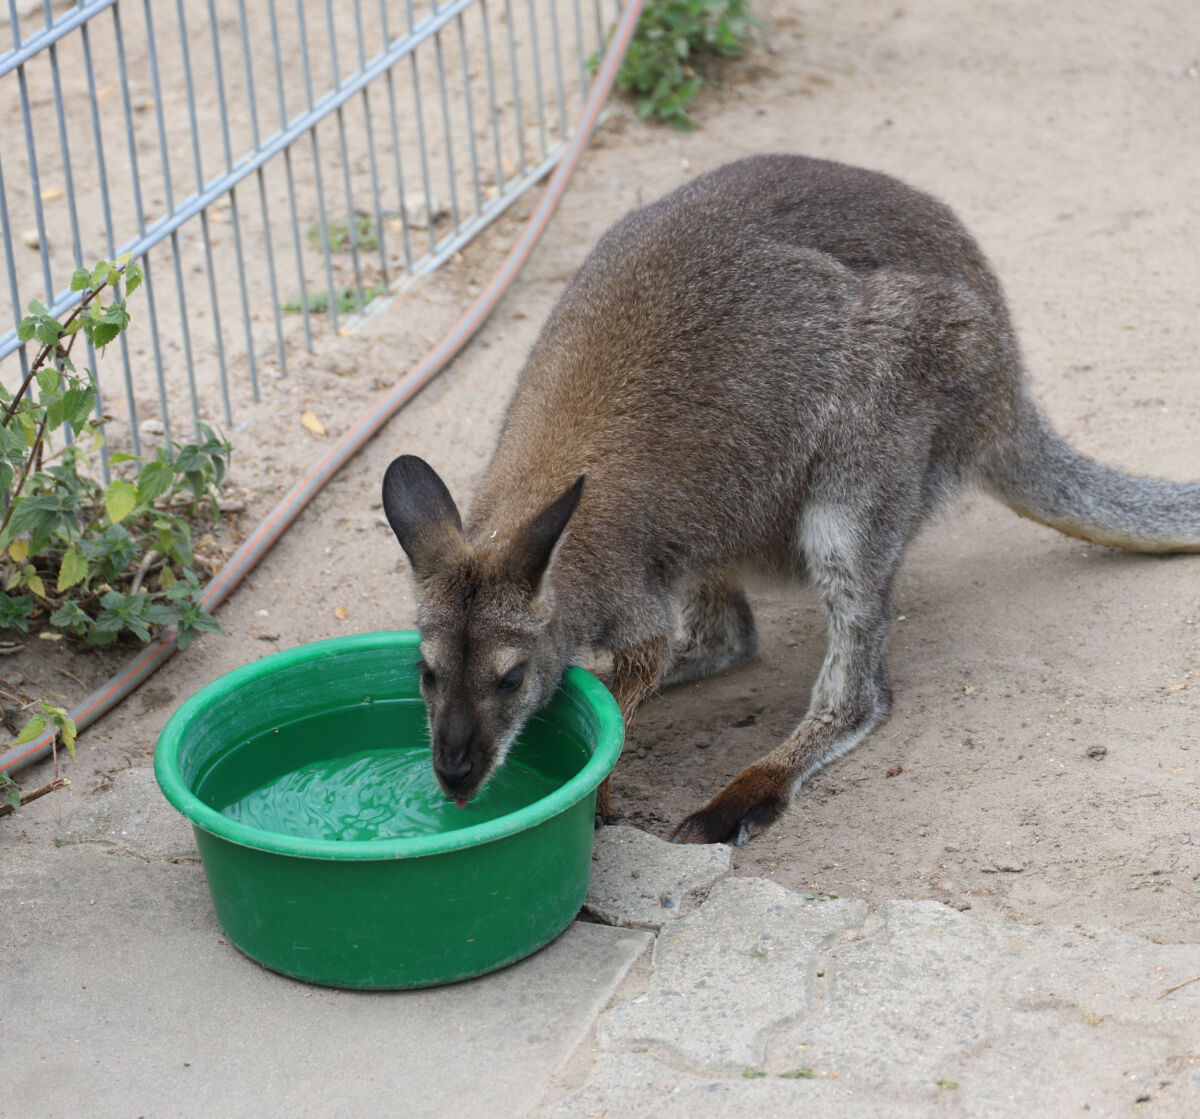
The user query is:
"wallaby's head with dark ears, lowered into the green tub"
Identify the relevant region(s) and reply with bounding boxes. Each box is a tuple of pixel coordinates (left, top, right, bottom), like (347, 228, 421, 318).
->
(383, 455, 583, 807)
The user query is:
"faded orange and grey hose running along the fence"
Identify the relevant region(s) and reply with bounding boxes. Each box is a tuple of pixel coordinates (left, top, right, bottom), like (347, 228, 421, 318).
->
(0, 0, 643, 773)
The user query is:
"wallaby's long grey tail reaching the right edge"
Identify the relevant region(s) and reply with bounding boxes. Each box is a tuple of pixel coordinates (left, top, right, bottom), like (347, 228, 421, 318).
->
(983, 396, 1200, 552)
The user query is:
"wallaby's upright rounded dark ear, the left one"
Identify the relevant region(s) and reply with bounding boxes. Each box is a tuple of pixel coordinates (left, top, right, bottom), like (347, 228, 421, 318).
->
(383, 455, 464, 579)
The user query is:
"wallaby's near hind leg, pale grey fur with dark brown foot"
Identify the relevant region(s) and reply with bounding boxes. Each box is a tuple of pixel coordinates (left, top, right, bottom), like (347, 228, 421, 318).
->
(673, 504, 908, 845)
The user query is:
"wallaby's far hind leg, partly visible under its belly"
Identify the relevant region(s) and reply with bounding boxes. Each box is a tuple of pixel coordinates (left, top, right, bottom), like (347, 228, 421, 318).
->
(662, 575, 758, 687)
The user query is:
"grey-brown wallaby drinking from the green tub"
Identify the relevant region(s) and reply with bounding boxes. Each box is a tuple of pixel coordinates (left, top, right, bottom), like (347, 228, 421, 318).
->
(383, 156, 1200, 844)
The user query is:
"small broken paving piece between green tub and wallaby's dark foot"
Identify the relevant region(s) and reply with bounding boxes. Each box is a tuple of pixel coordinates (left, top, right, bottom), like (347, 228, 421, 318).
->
(583, 826, 733, 929)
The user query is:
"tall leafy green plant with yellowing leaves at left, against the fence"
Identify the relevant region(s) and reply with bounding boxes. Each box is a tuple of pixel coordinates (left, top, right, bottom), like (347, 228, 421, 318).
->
(0, 258, 230, 653)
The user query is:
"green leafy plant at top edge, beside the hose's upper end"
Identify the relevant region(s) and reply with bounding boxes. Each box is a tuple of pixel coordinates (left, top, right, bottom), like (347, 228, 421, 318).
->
(592, 0, 760, 131)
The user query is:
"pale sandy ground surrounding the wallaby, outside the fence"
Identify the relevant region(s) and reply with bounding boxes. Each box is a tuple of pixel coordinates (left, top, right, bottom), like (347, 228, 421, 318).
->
(0, 0, 1200, 941)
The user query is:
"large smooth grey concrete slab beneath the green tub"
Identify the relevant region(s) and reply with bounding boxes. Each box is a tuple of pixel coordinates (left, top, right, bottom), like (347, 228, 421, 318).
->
(0, 843, 650, 1119)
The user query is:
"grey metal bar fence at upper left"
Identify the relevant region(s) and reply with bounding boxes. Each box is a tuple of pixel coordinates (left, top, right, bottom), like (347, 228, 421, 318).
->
(0, 0, 618, 475)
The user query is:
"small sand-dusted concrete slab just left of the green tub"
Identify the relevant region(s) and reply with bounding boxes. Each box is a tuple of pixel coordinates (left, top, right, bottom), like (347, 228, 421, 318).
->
(54, 766, 199, 862)
